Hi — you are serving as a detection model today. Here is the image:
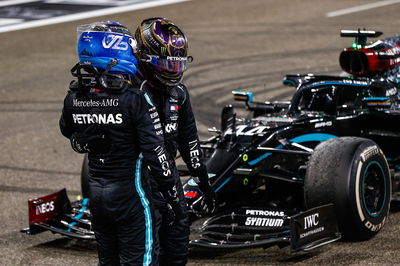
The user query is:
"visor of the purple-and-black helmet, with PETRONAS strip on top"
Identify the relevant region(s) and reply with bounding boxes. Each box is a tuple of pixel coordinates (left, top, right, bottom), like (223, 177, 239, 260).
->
(143, 55, 193, 75)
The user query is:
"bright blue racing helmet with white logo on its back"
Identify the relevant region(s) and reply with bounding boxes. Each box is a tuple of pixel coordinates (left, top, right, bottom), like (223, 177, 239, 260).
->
(77, 21, 137, 75)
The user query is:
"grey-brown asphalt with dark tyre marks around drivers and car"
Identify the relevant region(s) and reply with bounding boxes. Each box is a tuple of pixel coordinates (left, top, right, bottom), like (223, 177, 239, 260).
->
(0, 0, 400, 265)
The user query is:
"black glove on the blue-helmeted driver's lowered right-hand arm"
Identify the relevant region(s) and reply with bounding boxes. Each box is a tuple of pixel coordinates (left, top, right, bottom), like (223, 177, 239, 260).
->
(161, 186, 185, 226)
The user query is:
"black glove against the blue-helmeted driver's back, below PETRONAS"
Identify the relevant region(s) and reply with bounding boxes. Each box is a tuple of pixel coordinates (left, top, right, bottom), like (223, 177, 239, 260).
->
(70, 124, 111, 153)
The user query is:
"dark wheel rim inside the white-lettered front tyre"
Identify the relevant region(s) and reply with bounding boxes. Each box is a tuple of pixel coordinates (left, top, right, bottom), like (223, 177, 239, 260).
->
(361, 161, 386, 217)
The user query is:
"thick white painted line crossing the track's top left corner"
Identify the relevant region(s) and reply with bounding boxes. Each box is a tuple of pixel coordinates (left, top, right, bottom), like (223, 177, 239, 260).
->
(0, 0, 190, 33)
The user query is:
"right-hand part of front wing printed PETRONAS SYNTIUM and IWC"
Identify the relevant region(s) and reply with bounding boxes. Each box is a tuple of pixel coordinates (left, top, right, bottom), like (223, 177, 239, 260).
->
(190, 204, 341, 252)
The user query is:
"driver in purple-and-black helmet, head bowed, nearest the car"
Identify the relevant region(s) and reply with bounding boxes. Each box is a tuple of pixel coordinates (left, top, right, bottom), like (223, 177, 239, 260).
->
(135, 18, 216, 265)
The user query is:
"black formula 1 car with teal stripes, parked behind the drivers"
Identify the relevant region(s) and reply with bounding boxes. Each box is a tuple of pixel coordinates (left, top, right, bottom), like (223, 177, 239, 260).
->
(21, 30, 400, 251)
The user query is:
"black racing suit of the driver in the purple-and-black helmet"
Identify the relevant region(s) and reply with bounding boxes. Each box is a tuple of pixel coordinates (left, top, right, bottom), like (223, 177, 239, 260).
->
(141, 81, 208, 265)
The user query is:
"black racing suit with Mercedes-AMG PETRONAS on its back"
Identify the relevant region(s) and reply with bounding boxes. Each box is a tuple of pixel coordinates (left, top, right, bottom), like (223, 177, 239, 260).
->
(60, 85, 174, 265)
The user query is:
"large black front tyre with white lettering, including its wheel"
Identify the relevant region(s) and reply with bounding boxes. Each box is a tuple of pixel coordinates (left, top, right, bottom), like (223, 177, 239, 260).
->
(304, 137, 391, 241)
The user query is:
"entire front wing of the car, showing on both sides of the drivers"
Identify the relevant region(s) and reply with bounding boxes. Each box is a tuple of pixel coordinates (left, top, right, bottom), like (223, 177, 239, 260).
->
(21, 189, 341, 252)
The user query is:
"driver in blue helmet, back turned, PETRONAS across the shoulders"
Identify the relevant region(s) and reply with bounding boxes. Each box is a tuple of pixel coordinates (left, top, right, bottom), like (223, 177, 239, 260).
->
(60, 21, 175, 265)
